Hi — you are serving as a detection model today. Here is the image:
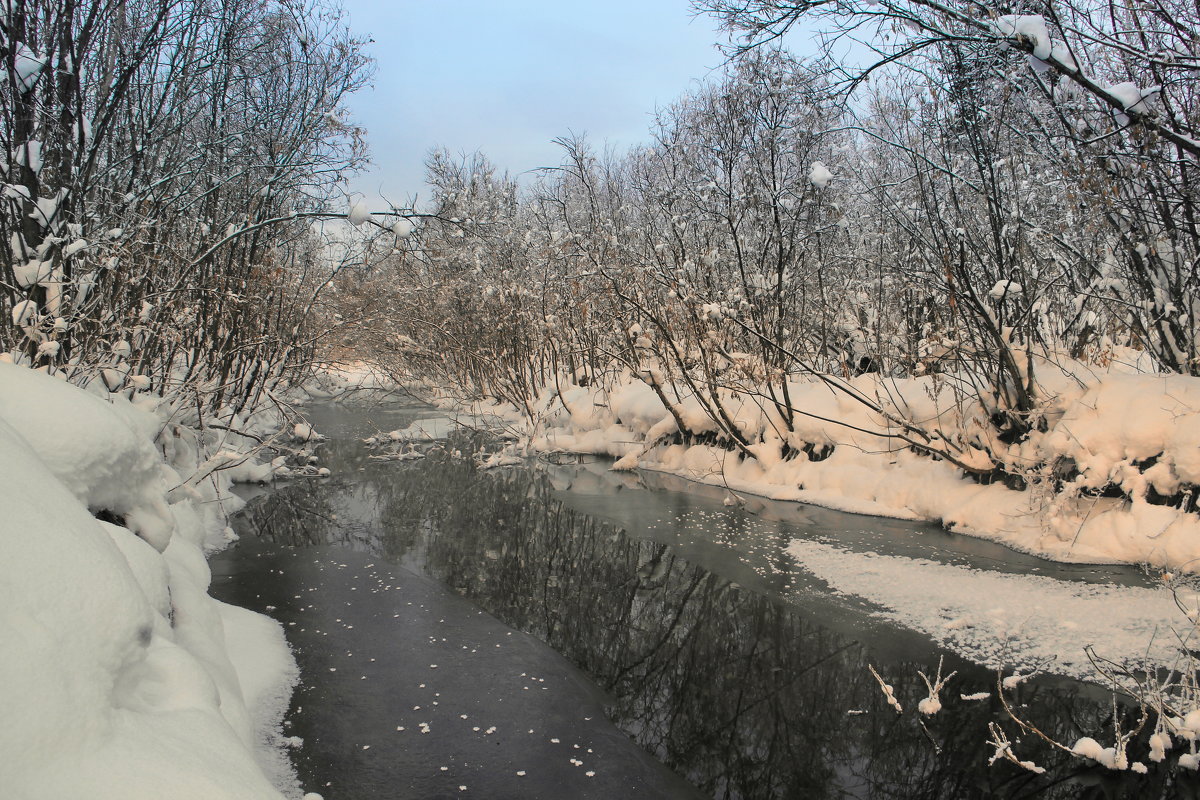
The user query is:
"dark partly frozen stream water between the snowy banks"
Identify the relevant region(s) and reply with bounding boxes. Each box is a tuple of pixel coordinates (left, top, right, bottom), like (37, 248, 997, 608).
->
(212, 409, 1194, 799)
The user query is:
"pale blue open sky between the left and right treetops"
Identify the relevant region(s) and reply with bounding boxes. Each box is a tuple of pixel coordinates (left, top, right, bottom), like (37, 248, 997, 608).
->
(343, 0, 724, 209)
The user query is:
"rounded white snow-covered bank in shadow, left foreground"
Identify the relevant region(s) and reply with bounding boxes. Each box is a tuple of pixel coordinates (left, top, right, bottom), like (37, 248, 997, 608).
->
(0, 362, 299, 800)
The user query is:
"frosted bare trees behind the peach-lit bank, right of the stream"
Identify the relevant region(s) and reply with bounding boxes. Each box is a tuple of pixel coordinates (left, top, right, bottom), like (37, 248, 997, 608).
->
(348, 0, 1200, 474)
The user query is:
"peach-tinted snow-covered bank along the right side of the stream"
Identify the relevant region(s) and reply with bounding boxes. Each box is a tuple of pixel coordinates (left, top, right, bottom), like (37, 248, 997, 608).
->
(444, 365, 1200, 571)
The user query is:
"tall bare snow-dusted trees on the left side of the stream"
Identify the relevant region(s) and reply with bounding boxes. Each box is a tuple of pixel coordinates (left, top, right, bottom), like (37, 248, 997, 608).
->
(0, 0, 370, 409)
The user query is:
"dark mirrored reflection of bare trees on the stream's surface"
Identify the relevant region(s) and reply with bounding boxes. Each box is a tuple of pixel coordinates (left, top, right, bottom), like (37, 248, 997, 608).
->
(234, 456, 1177, 798)
